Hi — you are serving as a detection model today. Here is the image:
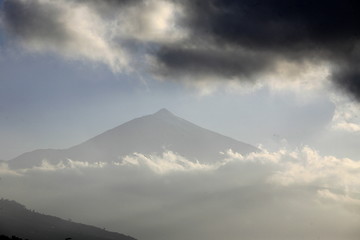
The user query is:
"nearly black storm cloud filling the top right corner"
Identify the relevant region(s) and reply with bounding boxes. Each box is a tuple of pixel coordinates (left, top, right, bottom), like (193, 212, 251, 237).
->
(179, 0, 360, 50)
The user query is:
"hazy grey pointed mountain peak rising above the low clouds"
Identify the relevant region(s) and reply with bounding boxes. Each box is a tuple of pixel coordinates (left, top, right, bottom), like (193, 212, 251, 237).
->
(9, 109, 258, 168)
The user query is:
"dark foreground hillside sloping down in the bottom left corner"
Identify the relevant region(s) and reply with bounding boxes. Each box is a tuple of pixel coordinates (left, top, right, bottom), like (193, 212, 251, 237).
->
(0, 199, 135, 240)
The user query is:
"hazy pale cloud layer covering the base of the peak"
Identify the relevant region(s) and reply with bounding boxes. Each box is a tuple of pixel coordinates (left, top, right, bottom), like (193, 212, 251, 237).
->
(0, 147, 360, 240)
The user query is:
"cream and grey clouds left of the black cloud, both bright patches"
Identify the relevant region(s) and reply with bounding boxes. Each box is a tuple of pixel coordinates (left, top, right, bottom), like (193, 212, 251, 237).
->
(2, 0, 181, 72)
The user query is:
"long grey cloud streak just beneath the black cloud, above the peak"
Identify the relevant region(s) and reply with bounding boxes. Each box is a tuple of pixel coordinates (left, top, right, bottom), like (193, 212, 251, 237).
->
(153, 47, 270, 79)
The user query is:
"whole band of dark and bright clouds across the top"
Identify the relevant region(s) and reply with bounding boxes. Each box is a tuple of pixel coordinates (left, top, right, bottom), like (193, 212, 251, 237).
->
(2, 0, 360, 100)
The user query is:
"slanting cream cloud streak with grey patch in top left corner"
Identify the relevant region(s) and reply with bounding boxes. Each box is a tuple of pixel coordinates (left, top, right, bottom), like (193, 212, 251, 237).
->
(3, 0, 128, 71)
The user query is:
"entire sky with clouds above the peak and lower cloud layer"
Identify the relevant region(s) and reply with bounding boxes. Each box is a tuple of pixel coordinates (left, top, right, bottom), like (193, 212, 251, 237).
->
(0, 0, 360, 160)
